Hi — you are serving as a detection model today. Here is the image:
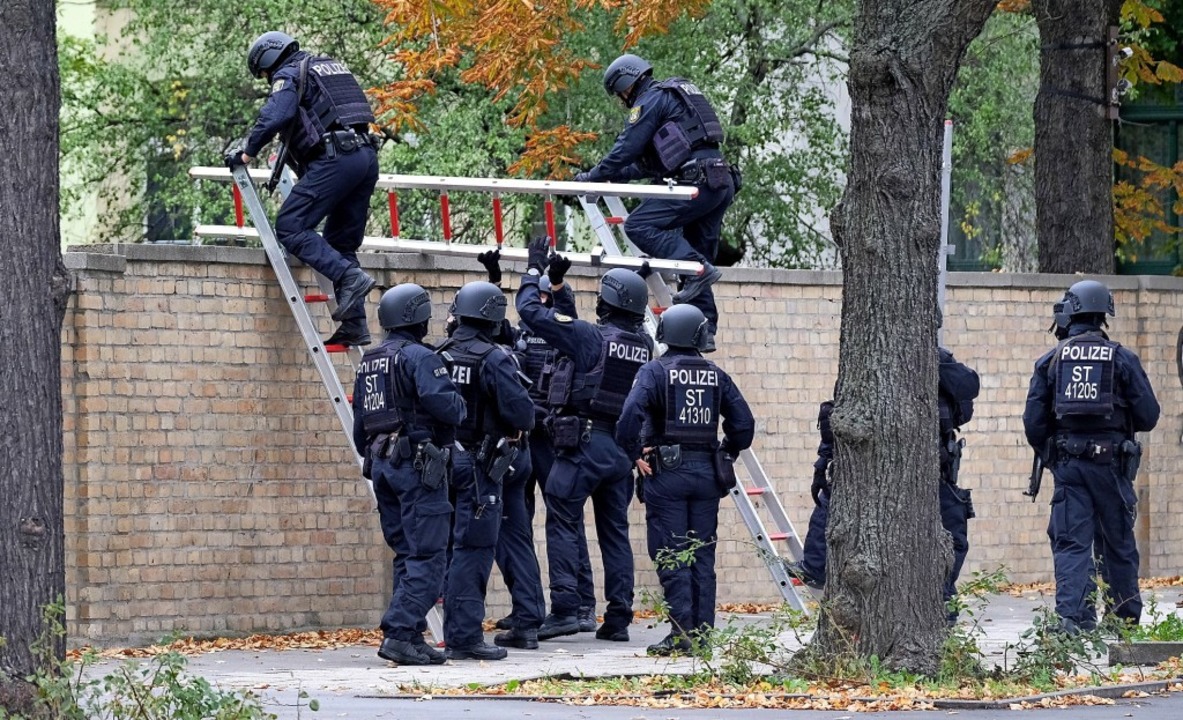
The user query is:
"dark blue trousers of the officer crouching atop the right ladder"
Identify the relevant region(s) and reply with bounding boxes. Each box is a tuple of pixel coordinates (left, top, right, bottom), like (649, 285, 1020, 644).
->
(625, 183, 735, 331)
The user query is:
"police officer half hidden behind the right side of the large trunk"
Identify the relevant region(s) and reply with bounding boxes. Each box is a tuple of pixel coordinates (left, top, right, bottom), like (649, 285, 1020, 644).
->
(937, 348, 982, 625)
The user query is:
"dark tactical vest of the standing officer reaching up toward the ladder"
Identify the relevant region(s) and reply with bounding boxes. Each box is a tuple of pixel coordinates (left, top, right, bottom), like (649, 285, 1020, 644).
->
(549, 325, 653, 422)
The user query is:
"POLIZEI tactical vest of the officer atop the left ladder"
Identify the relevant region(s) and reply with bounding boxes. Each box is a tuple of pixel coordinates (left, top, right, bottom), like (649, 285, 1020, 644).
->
(289, 57, 374, 157)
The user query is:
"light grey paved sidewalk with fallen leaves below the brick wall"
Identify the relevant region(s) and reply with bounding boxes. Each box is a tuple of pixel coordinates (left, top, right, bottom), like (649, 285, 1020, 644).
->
(83, 588, 1183, 719)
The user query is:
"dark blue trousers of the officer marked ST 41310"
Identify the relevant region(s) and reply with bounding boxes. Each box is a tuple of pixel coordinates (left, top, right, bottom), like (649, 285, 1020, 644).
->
(645, 460, 719, 634)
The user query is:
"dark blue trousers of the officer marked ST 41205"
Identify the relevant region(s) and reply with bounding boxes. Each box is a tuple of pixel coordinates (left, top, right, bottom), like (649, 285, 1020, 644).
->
(1047, 456, 1142, 628)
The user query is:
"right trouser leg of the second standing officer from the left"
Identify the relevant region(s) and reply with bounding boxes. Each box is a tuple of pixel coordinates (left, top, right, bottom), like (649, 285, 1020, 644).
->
(496, 439, 547, 630)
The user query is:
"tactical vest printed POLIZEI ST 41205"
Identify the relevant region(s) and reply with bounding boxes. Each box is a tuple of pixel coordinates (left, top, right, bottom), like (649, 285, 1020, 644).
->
(1049, 332, 1124, 432)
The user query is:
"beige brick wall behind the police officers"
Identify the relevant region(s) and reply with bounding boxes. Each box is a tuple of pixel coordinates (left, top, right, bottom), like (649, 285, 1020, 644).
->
(62, 246, 1183, 643)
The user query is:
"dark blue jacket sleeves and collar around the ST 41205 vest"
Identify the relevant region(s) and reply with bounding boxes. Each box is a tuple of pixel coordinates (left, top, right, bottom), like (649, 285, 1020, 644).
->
(1023, 323, 1161, 460)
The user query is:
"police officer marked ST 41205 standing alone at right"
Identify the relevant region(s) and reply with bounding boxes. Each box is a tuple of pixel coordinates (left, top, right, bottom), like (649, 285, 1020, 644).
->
(1023, 280, 1159, 633)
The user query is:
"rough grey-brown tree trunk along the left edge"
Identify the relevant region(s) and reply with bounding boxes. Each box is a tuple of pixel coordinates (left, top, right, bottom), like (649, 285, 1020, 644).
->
(0, 0, 70, 689)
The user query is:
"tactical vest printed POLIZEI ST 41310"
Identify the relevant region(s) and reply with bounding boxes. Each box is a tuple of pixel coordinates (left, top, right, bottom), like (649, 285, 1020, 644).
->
(658, 355, 723, 449)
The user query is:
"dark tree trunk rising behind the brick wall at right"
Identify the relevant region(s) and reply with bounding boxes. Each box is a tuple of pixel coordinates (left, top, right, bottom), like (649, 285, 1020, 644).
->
(1032, 0, 1121, 274)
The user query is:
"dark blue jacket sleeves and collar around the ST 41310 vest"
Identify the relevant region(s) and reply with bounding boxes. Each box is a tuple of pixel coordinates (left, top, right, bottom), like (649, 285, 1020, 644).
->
(616, 348, 756, 461)
